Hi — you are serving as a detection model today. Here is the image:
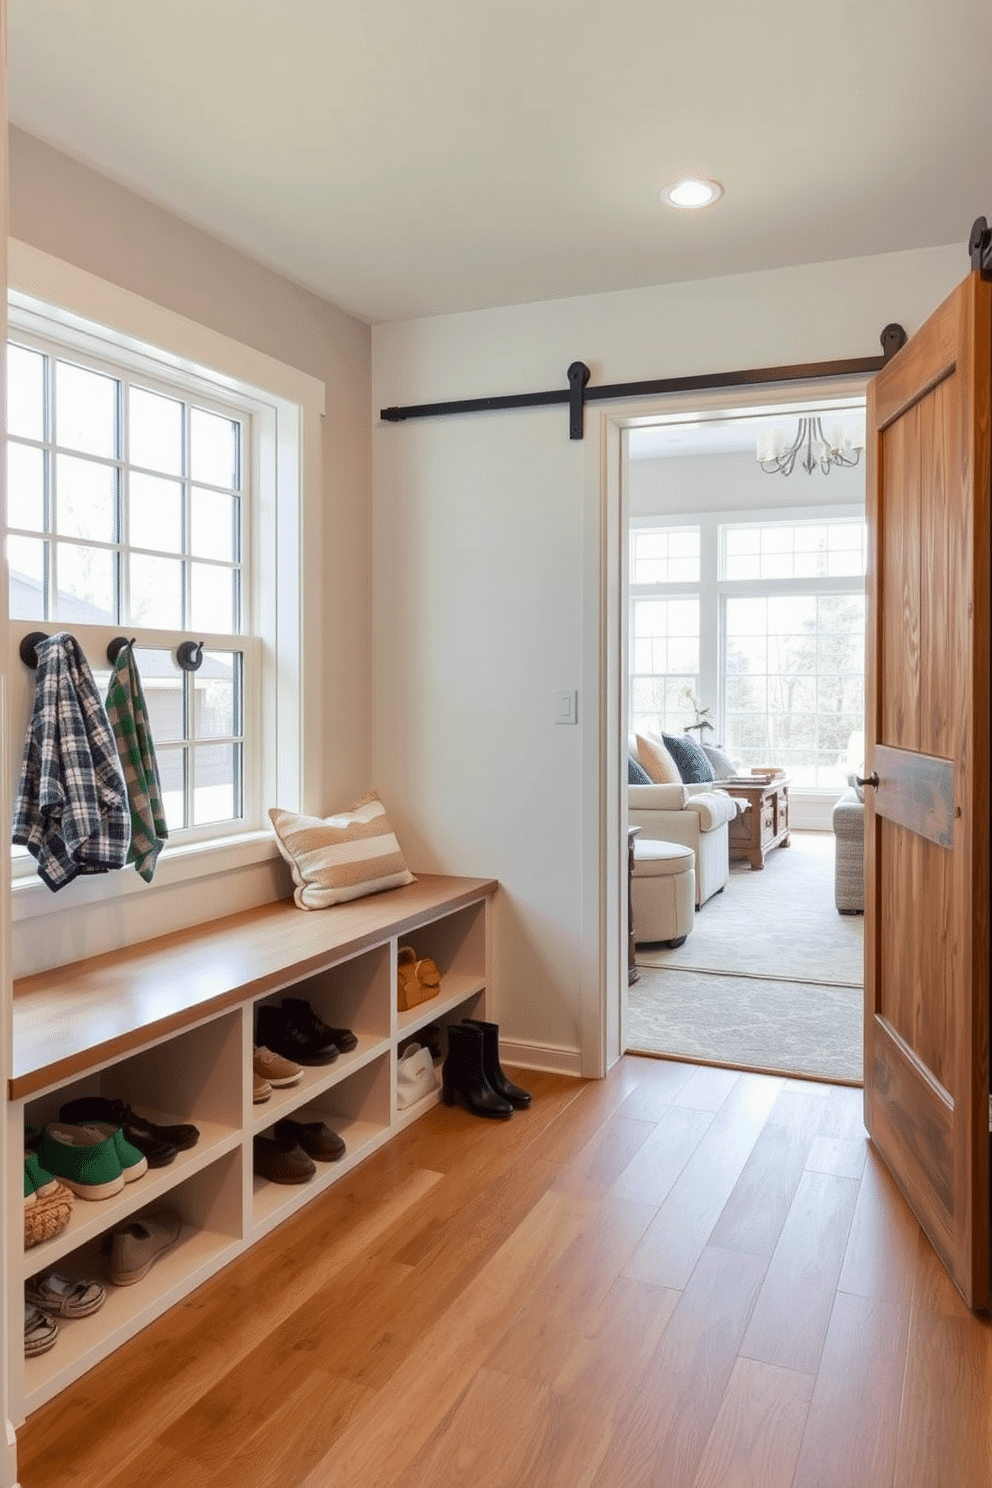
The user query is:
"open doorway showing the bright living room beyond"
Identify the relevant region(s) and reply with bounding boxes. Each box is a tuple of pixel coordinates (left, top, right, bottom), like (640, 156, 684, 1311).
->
(620, 393, 866, 1083)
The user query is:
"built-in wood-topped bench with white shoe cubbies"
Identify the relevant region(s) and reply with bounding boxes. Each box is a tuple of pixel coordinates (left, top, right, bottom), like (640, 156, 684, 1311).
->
(7, 876, 497, 1420)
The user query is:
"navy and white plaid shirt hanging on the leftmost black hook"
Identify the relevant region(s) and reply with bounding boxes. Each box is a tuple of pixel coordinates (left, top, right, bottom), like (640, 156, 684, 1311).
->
(12, 631, 131, 893)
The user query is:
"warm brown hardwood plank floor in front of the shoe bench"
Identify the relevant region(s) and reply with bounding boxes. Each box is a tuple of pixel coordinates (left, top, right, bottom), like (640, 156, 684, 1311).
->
(18, 1056, 992, 1488)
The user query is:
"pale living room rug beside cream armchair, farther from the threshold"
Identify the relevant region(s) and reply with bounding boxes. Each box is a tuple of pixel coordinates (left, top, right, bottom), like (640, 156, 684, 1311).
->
(637, 832, 864, 987)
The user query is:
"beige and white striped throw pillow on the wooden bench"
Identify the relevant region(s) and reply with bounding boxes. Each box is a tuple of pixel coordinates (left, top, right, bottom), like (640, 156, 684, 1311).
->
(269, 790, 415, 909)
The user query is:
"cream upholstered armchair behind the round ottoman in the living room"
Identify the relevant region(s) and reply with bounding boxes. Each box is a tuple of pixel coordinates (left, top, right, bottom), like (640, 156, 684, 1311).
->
(628, 784, 738, 909)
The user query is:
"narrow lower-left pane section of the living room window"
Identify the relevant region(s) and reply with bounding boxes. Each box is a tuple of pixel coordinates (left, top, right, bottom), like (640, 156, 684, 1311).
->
(631, 595, 699, 734)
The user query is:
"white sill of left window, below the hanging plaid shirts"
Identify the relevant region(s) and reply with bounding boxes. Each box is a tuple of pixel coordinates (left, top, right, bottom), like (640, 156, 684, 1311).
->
(10, 830, 280, 924)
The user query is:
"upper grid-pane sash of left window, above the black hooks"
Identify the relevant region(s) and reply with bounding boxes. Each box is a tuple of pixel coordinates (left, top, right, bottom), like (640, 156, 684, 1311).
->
(7, 344, 247, 635)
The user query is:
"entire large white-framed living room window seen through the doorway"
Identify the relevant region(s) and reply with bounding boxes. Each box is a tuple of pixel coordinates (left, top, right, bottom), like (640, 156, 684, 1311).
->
(629, 510, 866, 792)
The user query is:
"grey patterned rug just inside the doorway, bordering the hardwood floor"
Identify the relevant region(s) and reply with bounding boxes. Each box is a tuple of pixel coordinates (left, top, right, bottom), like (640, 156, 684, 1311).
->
(626, 963, 863, 1083)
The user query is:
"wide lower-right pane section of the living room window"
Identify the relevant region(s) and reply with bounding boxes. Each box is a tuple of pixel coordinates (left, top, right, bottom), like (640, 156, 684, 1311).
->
(723, 592, 864, 787)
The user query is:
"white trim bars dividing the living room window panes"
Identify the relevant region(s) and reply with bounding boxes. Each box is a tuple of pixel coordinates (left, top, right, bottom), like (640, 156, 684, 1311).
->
(628, 503, 864, 805)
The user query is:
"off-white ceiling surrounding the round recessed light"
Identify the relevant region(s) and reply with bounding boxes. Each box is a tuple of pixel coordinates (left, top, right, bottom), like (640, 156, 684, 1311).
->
(9, 0, 992, 321)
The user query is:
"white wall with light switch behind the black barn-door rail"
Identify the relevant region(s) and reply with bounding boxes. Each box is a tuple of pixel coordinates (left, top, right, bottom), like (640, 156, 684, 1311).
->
(372, 243, 968, 1073)
